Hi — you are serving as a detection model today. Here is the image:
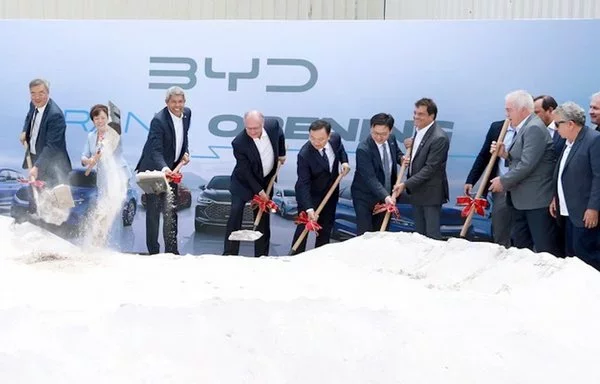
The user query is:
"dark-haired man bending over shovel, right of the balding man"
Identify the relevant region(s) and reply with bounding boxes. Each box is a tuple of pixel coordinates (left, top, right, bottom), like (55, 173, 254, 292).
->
(292, 120, 350, 253)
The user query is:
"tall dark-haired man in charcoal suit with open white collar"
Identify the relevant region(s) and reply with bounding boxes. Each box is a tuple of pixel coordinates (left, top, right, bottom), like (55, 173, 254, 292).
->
(399, 98, 450, 240)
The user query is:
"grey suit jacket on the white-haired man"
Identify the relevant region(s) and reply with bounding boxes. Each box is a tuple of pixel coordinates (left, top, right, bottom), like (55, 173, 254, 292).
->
(500, 114, 556, 210)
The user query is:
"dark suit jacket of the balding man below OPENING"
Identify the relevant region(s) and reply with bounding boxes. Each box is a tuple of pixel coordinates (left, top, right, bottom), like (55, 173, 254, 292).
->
(230, 119, 285, 201)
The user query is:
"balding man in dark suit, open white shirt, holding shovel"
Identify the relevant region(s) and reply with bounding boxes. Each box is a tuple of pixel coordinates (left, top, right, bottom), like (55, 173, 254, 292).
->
(223, 111, 286, 257)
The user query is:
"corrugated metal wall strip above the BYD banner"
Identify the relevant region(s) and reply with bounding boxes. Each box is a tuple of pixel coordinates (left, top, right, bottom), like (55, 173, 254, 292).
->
(0, 0, 600, 20)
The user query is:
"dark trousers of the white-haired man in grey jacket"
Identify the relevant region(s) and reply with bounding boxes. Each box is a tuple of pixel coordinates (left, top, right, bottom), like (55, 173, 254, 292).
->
(512, 208, 564, 257)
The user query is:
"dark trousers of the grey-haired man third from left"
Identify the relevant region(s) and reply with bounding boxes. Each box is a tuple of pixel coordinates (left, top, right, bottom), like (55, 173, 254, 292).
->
(146, 183, 179, 255)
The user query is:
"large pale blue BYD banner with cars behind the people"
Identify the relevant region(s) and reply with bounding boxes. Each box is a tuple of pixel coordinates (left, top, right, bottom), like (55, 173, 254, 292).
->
(0, 20, 600, 254)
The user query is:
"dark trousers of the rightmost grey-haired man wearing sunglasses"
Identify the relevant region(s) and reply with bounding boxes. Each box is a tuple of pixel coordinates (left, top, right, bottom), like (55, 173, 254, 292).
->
(565, 217, 600, 271)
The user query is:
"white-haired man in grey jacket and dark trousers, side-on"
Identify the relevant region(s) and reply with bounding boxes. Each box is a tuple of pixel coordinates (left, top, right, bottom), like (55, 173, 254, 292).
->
(490, 90, 563, 256)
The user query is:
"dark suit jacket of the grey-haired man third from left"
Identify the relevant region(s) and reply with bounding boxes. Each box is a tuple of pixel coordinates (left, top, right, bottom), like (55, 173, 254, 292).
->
(135, 107, 192, 172)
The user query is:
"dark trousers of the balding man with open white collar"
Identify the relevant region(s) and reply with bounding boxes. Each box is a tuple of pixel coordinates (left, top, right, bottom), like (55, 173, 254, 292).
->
(223, 196, 271, 257)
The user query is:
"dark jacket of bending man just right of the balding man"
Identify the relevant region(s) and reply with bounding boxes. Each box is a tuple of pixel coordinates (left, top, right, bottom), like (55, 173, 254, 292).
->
(295, 132, 348, 211)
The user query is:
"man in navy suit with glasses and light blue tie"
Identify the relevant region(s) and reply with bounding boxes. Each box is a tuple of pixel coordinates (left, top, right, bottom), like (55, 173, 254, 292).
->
(350, 113, 403, 236)
